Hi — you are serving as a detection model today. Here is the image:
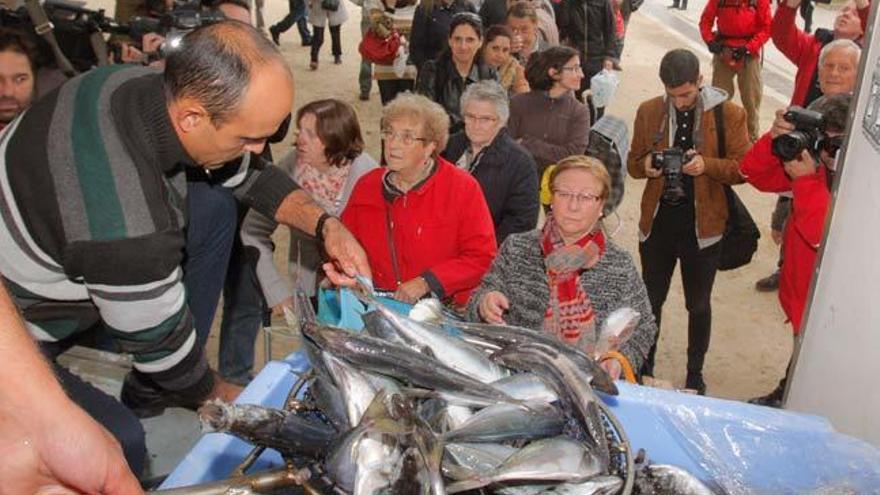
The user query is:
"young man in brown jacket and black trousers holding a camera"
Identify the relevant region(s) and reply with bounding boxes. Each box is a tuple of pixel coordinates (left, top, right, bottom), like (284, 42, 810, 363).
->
(627, 49, 749, 394)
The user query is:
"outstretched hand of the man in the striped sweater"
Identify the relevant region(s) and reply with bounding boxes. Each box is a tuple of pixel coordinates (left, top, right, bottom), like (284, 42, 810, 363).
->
(324, 218, 373, 287)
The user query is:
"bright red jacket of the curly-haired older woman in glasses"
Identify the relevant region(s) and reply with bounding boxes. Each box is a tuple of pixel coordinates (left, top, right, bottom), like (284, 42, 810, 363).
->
(342, 158, 496, 306)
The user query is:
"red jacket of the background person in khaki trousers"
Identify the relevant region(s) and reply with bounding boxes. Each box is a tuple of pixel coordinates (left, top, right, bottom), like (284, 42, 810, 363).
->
(700, 0, 770, 56)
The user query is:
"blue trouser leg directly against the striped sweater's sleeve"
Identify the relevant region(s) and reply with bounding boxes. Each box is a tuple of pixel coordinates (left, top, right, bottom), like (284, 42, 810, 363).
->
(183, 178, 238, 346)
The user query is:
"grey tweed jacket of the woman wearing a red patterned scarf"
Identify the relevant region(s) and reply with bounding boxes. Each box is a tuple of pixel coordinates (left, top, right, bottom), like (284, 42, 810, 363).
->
(467, 230, 657, 373)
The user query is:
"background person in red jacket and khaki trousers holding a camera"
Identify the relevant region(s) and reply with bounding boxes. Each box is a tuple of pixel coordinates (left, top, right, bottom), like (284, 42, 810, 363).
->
(700, 0, 770, 141)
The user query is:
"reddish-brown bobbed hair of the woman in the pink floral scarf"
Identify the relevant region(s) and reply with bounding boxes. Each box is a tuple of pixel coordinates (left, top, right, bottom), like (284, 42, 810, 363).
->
(296, 98, 364, 167)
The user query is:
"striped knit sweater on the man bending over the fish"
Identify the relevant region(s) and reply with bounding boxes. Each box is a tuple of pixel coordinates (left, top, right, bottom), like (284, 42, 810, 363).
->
(0, 66, 295, 394)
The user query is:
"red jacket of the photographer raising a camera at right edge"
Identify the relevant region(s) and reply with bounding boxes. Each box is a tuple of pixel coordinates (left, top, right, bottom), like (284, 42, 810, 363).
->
(740, 133, 831, 335)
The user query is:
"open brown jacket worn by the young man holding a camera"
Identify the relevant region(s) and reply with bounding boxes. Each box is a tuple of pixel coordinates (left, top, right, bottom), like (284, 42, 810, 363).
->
(626, 86, 751, 248)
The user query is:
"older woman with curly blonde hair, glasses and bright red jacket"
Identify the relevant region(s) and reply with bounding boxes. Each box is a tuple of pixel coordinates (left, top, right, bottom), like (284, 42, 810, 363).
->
(342, 93, 496, 308)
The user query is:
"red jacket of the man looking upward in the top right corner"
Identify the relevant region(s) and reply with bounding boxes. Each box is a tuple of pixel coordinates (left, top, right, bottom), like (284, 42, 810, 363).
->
(770, 3, 870, 106)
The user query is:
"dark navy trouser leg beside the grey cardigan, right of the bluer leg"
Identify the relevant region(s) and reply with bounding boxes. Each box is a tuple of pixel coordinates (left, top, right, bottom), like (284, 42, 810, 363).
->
(219, 234, 269, 385)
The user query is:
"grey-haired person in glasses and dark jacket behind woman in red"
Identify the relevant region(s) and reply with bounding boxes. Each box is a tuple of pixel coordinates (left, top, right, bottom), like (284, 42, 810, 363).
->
(443, 81, 539, 245)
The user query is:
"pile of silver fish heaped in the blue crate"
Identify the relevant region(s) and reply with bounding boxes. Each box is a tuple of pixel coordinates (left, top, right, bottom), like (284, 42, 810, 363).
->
(194, 294, 712, 495)
